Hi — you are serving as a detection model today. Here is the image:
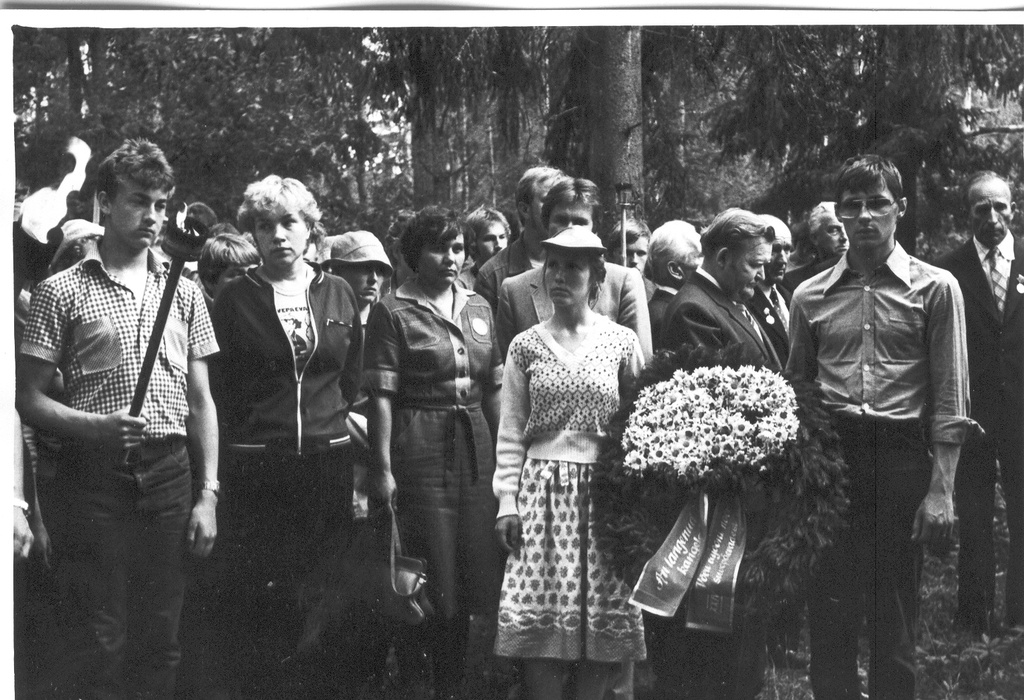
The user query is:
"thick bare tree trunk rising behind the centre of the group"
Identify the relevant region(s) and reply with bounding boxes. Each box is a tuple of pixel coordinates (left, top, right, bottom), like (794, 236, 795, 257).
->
(582, 27, 643, 223)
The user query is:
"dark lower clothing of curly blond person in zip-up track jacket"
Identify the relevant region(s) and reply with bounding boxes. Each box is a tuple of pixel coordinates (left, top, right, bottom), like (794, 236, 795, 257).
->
(216, 449, 352, 700)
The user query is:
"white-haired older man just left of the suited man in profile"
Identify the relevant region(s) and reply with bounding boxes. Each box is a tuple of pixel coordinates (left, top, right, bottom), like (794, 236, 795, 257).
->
(647, 219, 703, 350)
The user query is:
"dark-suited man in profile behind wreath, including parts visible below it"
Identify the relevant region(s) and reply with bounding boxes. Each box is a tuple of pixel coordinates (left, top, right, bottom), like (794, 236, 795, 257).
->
(644, 209, 782, 700)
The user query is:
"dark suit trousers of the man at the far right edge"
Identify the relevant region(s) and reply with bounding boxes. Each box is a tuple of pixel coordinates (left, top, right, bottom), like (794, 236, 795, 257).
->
(955, 426, 1024, 632)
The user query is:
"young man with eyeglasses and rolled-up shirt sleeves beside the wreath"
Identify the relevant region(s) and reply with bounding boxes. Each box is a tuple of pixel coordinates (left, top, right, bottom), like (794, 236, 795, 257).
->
(786, 156, 972, 700)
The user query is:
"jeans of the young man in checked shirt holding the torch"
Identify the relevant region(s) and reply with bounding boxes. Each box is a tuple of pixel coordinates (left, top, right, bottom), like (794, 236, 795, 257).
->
(39, 438, 191, 698)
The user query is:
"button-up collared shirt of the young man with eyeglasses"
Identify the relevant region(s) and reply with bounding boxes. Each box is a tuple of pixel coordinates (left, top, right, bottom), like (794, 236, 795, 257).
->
(786, 244, 971, 444)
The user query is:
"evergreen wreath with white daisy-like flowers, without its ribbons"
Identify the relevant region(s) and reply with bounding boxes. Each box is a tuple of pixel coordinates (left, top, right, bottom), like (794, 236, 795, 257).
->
(590, 345, 849, 615)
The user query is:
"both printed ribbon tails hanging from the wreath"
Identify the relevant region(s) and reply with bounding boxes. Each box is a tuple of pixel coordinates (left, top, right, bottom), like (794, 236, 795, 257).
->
(630, 492, 746, 632)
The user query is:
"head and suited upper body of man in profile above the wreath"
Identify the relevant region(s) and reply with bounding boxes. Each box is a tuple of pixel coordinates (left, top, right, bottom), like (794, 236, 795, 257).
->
(662, 209, 782, 371)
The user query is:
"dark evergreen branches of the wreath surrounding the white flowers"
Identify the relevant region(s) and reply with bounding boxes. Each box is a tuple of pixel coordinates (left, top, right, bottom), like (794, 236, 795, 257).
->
(591, 345, 848, 614)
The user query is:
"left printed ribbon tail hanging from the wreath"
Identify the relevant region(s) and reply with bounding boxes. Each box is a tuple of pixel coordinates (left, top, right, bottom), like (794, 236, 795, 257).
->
(630, 492, 708, 617)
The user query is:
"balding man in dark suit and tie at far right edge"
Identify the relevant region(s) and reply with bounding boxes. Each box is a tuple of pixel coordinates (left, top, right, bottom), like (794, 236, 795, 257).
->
(936, 171, 1024, 632)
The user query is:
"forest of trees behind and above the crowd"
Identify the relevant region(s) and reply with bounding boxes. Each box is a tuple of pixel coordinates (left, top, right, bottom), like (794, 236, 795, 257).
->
(13, 20, 1024, 258)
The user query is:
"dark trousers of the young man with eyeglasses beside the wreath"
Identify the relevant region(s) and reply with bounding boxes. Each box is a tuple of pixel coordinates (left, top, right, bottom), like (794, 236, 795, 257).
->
(808, 419, 931, 700)
